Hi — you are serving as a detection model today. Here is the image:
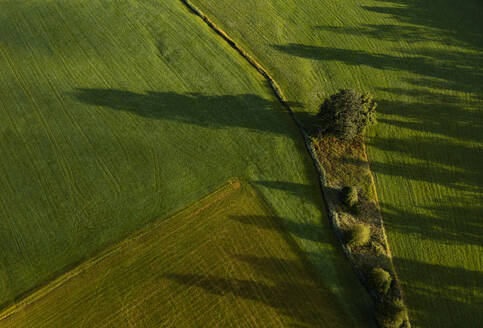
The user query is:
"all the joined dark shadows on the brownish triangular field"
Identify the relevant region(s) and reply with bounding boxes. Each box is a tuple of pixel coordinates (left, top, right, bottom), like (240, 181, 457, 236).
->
(165, 215, 349, 327)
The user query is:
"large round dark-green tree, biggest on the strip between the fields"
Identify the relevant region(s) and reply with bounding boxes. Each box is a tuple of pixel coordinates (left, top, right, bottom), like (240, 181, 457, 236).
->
(318, 89, 377, 140)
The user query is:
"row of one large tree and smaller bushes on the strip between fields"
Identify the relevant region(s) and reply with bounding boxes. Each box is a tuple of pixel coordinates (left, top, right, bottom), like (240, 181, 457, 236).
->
(316, 93, 407, 328)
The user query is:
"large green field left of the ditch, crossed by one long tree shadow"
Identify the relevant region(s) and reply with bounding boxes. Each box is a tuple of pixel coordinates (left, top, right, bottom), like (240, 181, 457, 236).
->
(0, 0, 376, 325)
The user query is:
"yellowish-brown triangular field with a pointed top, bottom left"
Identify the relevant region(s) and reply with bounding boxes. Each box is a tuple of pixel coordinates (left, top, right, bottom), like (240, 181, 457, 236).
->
(0, 181, 352, 328)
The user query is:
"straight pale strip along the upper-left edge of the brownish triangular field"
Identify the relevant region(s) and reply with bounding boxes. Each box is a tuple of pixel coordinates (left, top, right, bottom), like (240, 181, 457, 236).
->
(0, 178, 242, 321)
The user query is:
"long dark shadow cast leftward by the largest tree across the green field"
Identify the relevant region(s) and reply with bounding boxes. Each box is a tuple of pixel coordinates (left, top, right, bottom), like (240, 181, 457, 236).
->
(74, 89, 297, 137)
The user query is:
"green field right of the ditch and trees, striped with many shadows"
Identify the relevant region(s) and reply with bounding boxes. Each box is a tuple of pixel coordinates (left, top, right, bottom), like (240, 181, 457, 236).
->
(189, 0, 483, 327)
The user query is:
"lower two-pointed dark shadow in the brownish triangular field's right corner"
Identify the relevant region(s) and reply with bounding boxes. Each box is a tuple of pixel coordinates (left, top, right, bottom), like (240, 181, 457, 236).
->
(165, 254, 356, 327)
